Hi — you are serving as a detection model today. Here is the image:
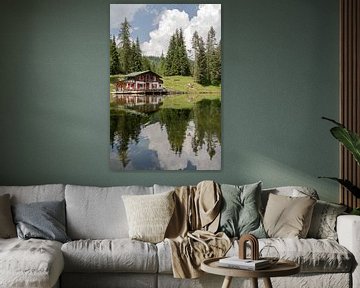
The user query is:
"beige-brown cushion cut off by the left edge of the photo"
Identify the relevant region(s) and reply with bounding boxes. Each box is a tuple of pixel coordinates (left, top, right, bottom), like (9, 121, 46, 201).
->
(0, 194, 16, 238)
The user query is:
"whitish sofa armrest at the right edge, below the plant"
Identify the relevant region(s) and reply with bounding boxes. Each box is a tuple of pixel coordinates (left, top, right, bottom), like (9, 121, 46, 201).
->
(336, 215, 360, 287)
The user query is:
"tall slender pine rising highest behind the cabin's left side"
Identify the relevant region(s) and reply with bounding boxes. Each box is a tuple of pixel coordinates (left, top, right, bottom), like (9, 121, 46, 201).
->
(119, 18, 132, 73)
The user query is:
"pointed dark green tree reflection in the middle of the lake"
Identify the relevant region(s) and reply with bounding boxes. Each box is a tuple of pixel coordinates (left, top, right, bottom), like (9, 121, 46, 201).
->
(159, 109, 191, 155)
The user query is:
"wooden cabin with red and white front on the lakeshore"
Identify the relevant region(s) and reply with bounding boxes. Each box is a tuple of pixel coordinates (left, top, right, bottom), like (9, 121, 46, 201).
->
(116, 70, 166, 93)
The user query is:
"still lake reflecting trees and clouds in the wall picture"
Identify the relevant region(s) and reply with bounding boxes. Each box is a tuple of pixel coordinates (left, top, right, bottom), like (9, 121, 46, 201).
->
(110, 95, 221, 171)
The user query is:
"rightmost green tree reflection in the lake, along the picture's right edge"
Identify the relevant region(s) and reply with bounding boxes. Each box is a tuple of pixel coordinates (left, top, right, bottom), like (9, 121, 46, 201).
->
(191, 99, 221, 159)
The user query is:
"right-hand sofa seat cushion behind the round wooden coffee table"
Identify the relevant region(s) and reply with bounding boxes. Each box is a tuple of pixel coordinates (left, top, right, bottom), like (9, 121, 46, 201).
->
(157, 238, 355, 274)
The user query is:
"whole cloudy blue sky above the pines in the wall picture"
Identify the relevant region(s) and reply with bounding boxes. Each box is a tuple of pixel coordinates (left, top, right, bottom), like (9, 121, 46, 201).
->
(110, 4, 221, 56)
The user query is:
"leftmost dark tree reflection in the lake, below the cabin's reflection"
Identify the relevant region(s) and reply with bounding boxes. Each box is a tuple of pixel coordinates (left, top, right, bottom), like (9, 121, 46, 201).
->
(110, 111, 148, 167)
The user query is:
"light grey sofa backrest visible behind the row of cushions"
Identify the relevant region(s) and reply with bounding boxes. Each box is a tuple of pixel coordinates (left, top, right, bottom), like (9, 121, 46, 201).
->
(0, 184, 319, 240)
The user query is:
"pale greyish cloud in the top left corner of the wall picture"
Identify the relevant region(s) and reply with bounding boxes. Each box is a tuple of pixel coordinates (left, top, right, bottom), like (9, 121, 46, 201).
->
(110, 4, 146, 30)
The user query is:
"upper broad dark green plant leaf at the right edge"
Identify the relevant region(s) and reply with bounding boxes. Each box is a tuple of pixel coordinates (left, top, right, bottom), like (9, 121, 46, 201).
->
(323, 117, 360, 165)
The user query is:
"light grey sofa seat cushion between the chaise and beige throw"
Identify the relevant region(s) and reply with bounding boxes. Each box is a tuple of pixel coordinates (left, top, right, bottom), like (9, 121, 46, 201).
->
(61, 238, 158, 273)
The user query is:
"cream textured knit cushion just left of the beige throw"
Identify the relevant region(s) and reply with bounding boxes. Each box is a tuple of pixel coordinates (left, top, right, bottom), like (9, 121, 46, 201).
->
(122, 191, 175, 243)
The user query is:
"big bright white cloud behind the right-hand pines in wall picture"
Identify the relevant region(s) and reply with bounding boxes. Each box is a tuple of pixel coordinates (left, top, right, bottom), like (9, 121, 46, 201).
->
(141, 4, 221, 56)
